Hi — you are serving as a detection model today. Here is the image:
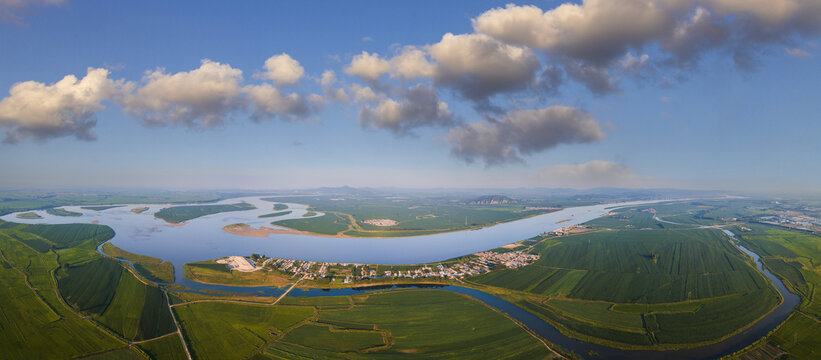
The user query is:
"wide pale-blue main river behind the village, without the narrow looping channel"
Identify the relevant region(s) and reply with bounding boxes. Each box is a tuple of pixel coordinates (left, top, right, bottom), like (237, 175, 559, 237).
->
(0, 197, 668, 281)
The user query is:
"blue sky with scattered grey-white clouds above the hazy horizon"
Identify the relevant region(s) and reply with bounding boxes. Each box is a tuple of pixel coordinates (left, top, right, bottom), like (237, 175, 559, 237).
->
(0, 0, 821, 192)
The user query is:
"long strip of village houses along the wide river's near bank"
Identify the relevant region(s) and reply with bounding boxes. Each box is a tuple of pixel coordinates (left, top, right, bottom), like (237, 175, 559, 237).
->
(224, 250, 539, 284)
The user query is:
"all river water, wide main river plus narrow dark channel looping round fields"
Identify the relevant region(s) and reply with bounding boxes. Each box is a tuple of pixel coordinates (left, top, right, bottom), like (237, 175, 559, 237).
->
(0, 197, 800, 359)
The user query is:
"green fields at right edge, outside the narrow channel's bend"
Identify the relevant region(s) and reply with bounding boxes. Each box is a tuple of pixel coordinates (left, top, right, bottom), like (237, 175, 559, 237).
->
(732, 224, 821, 359)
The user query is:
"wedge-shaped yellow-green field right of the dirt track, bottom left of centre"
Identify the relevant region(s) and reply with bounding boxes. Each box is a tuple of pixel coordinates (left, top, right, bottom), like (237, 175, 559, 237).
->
(174, 302, 314, 359)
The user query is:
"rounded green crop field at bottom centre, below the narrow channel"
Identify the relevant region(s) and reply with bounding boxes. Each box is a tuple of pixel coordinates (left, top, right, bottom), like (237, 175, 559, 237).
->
(266, 289, 550, 359)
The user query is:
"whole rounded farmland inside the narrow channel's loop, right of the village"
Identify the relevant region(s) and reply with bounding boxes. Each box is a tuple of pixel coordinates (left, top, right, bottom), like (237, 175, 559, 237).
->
(469, 228, 780, 349)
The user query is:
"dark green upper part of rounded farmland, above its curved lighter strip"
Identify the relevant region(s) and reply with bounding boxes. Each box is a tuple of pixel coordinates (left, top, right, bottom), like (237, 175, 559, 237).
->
(470, 229, 768, 303)
